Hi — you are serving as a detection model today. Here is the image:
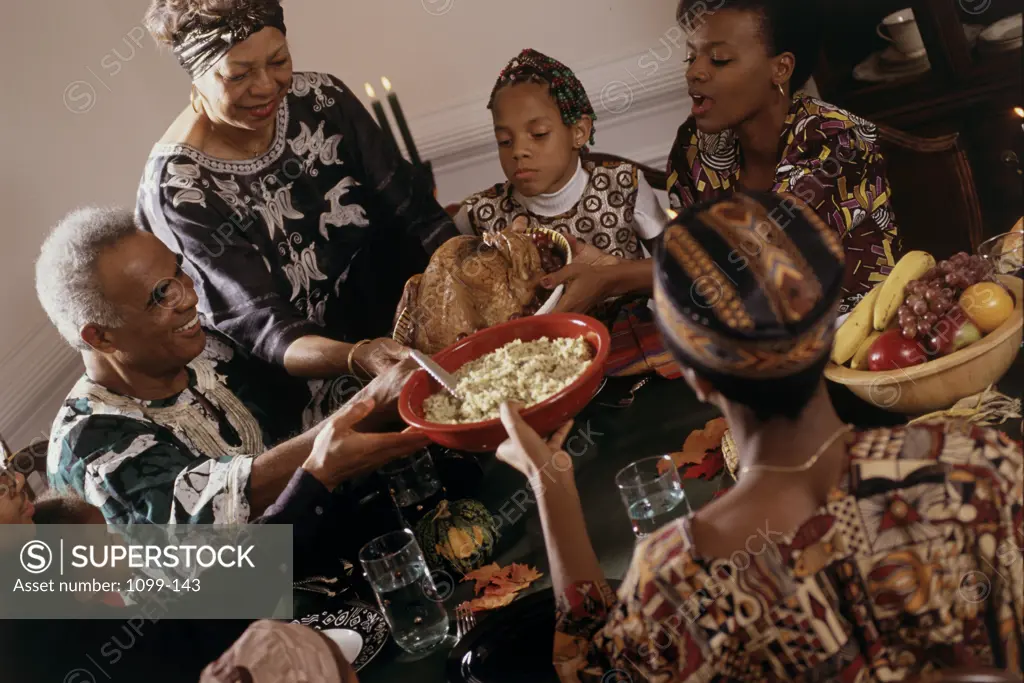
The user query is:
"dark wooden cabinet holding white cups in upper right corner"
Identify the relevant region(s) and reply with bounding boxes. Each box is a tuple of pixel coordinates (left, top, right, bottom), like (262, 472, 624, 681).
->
(814, 0, 1024, 240)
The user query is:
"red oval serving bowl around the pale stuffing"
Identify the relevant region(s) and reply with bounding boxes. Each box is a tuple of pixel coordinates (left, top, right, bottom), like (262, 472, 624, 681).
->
(398, 313, 611, 453)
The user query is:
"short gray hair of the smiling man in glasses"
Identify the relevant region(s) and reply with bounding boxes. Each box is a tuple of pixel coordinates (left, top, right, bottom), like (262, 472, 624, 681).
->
(36, 207, 138, 350)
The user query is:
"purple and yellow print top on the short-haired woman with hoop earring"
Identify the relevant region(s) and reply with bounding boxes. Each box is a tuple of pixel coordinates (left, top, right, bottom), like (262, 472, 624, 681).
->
(669, 97, 902, 313)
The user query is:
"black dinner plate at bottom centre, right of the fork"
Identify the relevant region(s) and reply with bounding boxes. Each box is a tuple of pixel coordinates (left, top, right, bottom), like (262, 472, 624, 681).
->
(447, 582, 618, 683)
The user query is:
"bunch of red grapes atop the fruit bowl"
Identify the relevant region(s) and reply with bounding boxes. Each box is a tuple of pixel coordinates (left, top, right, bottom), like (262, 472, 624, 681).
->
(898, 252, 991, 340)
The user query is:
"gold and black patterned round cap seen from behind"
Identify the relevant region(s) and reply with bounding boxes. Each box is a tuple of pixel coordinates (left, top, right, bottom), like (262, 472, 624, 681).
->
(654, 194, 844, 379)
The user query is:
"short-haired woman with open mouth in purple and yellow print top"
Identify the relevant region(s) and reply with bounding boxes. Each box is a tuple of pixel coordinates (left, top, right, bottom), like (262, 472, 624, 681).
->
(669, 0, 902, 313)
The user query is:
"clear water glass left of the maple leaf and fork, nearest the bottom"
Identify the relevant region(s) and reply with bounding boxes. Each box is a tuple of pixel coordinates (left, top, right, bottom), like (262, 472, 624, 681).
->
(359, 528, 449, 654)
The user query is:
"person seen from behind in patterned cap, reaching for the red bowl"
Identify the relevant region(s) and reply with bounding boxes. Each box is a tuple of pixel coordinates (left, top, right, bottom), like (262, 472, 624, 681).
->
(498, 194, 1024, 683)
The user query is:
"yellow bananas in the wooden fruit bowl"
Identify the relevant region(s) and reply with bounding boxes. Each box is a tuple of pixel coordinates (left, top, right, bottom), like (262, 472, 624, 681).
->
(831, 251, 935, 370)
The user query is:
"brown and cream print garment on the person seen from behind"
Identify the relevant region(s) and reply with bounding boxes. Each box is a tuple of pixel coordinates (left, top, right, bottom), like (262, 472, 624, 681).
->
(555, 421, 1024, 683)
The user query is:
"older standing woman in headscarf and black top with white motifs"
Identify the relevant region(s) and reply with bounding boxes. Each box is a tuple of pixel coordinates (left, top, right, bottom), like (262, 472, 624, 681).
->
(137, 0, 457, 378)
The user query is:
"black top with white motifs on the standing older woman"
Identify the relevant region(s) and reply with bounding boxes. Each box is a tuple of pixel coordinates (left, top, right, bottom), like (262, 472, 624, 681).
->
(136, 72, 457, 365)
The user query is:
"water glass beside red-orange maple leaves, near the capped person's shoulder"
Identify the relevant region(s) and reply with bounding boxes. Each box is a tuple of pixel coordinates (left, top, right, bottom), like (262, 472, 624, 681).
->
(615, 456, 690, 539)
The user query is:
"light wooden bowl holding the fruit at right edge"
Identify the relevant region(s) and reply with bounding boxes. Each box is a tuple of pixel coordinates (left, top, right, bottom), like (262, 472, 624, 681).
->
(825, 275, 1024, 415)
